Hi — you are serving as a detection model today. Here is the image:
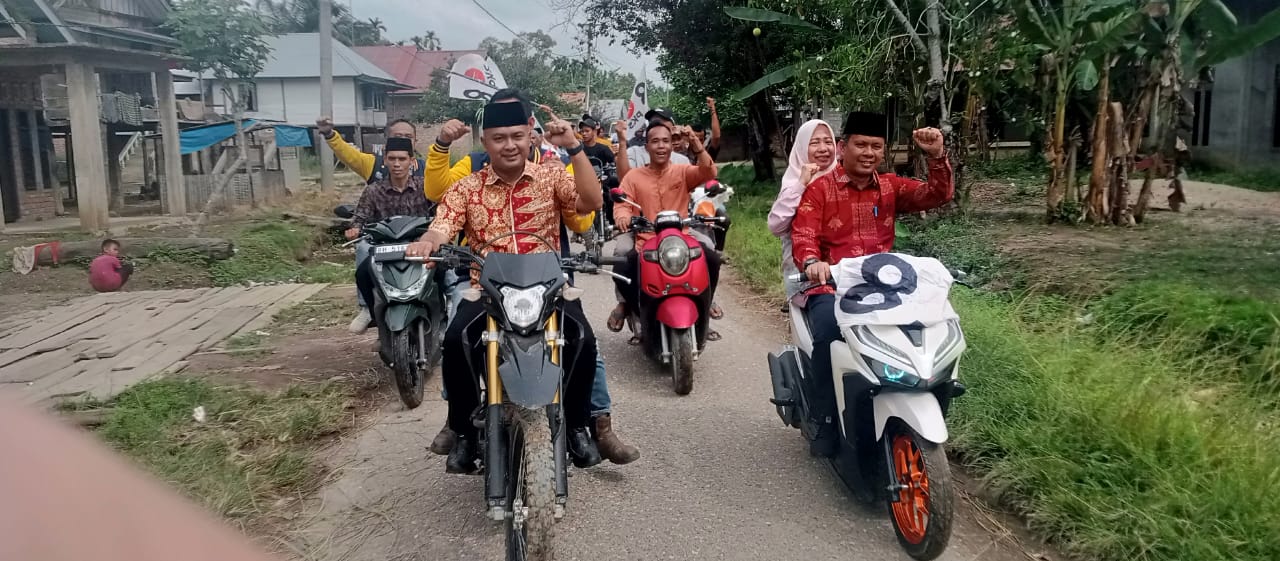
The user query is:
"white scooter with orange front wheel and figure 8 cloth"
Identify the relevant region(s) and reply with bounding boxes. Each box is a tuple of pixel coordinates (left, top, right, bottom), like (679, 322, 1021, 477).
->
(769, 254, 965, 561)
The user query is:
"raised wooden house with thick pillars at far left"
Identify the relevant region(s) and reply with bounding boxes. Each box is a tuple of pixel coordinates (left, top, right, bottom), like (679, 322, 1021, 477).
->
(0, 0, 186, 232)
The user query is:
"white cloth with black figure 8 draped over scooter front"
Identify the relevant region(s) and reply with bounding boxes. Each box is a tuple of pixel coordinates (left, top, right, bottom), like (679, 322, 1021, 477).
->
(831, 254, 960, 327)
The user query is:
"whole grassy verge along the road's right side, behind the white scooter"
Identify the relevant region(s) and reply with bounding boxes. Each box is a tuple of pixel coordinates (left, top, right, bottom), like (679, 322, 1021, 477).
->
(721, 159, 1280, 561)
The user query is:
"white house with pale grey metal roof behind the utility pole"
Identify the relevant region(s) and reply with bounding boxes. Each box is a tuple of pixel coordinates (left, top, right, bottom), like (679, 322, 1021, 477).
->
(204, 33, 410, 147)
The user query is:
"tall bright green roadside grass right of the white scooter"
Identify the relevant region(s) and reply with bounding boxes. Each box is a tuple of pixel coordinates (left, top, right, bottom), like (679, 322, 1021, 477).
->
(951, 291, 1280, 561)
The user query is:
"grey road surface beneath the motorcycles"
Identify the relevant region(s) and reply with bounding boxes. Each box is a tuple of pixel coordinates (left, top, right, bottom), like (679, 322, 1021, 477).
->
(289, 263, 1039, 561)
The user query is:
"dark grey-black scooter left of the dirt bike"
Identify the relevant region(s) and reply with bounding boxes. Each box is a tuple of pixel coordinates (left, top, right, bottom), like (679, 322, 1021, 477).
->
(334, 205, 448, 409)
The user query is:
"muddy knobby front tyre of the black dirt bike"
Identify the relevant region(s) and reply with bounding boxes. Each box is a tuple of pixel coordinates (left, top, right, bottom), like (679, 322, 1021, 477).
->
(507, 409, 556, 561)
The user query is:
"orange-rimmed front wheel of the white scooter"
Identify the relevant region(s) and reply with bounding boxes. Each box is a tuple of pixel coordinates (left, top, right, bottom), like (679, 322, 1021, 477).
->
(884, 419, 955, 561)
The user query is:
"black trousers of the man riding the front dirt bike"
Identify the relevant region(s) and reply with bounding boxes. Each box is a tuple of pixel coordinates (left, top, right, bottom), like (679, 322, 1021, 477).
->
(442, 300, 596, 438)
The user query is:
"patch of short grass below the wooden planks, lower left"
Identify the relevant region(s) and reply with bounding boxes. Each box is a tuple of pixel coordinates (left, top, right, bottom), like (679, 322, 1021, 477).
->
(100, 378, 348, 524)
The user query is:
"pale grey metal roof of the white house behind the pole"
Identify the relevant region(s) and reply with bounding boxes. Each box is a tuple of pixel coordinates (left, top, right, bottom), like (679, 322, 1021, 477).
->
(245, 33, 397, 82)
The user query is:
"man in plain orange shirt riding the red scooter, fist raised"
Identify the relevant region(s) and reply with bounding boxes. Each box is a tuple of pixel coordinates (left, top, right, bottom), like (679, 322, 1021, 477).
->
(608, 119, 719, 340)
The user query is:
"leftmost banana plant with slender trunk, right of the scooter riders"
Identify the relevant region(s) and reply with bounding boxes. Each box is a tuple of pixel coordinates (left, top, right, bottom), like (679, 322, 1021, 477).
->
(1018, 0, 1132, 222)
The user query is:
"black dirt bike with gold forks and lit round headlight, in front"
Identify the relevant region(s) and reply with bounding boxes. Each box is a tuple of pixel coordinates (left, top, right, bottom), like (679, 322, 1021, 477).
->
(408, 232, 624, 561)
